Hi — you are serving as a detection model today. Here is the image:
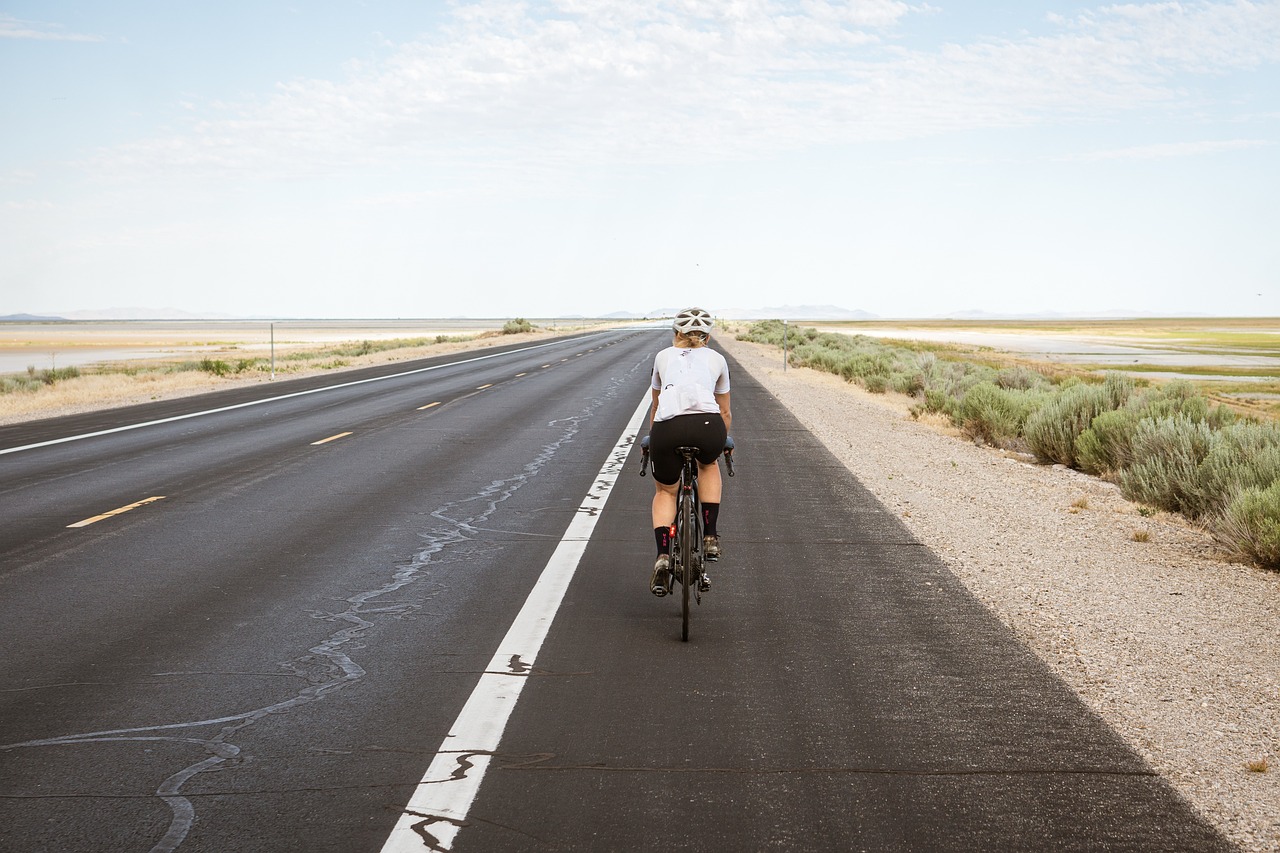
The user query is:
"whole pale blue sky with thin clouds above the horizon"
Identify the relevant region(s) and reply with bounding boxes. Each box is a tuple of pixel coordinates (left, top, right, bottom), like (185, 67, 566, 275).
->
(0, 0, 1280, 318)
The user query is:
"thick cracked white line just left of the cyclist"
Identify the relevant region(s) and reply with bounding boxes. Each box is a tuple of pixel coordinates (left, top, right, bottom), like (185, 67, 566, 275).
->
(381, 392, 653, 853)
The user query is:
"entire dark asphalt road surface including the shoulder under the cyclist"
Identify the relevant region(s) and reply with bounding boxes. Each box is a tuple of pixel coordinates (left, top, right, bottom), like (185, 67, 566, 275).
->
(0, 330, 1229, 852)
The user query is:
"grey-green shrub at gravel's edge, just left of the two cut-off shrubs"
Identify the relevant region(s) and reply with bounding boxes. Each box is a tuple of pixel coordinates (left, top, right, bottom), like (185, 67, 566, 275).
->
(1116, 415, 1212, 517)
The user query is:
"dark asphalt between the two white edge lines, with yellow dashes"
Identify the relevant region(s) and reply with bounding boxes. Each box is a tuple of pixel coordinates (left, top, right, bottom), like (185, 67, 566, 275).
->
(0, 324, 660, 850)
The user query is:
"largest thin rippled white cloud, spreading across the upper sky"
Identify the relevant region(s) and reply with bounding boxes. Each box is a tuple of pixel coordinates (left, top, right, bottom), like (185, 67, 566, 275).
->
(87, 0, 1280, 175)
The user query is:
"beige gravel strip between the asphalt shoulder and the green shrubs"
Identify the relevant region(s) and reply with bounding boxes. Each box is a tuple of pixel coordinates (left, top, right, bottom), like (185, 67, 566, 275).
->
(717, 336, 1280, 852)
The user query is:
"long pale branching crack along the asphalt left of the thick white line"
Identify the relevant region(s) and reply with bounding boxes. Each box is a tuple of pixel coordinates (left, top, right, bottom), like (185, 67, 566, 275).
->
(0, 368, 636, 853)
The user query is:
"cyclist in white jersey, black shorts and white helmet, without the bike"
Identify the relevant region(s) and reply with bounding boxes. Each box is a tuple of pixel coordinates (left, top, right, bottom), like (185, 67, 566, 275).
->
(649, 307, 732, 596)
